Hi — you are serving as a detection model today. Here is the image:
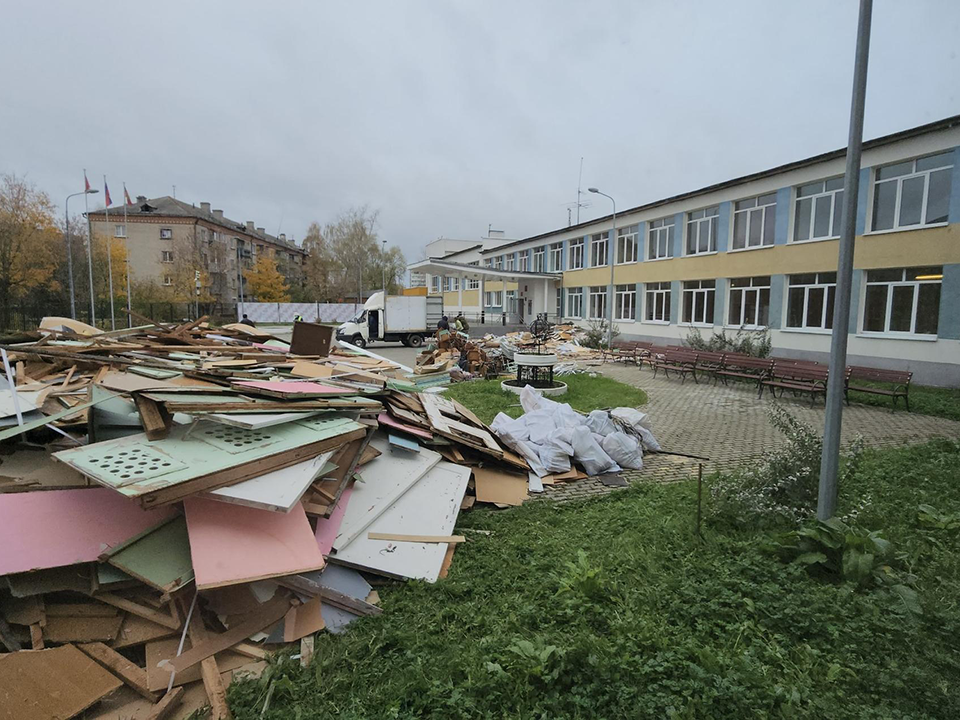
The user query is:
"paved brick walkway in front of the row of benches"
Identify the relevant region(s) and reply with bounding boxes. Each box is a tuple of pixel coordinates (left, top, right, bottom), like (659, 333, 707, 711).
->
(543, 363, 960, 500)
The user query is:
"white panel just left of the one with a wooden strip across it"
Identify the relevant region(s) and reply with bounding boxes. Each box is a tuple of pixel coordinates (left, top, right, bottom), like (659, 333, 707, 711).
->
(333, 433, 440, 550)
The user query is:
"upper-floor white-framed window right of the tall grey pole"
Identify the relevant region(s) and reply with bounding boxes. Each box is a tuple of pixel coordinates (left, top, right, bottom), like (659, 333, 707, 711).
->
(871, 153, 953, 231)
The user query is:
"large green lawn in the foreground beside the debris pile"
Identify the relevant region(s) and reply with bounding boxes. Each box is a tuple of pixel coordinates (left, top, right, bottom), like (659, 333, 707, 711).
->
(229, 436, 960, 720)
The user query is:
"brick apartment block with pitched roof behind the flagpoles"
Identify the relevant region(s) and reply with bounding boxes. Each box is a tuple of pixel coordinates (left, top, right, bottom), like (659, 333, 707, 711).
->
(90, 195, 306, 303)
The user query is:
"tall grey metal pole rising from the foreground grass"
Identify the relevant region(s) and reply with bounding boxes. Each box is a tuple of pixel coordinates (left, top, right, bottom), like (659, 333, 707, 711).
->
(817, 0, 873, 520)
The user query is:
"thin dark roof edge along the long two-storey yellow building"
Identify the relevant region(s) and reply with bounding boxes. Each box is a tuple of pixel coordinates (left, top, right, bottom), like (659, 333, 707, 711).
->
(480, 115, 960, 255)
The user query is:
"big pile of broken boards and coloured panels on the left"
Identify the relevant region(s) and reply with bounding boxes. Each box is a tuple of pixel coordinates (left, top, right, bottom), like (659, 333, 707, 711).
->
(0, 318, 586, 720)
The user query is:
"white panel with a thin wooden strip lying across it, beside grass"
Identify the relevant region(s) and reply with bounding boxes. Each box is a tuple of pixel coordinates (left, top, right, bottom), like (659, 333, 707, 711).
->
(335, 461, 470, 582)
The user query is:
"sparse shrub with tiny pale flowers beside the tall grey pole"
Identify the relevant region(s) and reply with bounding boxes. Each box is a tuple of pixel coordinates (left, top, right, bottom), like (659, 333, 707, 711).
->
(710, 405, 869, 527)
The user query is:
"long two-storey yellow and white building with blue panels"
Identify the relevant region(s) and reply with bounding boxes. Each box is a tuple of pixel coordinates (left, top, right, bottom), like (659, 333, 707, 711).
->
(410, 116, 960, 385)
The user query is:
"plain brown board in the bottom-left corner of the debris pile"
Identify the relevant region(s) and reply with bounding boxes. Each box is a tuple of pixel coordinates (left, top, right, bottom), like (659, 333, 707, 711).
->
(0, 645, 123, 720)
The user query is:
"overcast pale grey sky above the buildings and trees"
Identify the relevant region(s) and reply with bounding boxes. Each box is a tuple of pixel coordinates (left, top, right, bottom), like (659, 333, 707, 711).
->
(0, 0, 960, 260)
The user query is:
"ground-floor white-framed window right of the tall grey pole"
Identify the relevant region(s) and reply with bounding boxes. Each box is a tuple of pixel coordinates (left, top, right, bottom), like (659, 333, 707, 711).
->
(863, 267, 943, 336)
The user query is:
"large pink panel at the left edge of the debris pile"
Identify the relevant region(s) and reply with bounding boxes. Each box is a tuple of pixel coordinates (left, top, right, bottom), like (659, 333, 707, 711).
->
(0, 488, 174, 575)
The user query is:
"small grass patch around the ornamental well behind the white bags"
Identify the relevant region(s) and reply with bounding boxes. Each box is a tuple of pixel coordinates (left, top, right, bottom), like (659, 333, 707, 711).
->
(444, 374, 647, 423)
